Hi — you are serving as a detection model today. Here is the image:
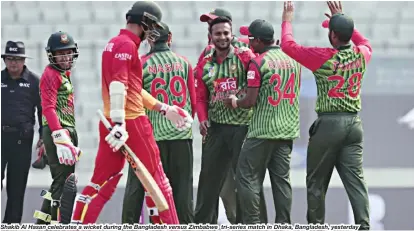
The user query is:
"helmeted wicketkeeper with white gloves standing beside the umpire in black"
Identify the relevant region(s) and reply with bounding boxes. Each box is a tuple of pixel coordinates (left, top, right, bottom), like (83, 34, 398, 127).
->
(34, 32, 81, 224)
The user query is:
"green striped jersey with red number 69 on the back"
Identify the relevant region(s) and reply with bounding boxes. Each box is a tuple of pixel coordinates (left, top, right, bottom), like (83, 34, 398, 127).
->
(142, 44, 195, 141)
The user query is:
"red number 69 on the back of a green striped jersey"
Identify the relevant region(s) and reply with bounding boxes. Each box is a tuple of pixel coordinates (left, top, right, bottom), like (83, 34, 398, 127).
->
(151, 76, 187, 108)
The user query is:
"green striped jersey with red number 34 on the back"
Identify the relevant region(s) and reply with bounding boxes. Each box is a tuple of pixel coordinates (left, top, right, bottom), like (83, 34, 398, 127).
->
(247, 46, 301, 140)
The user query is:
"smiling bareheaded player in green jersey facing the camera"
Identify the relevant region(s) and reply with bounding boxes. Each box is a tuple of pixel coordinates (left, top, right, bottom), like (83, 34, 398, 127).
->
(195, 17, 254, 224)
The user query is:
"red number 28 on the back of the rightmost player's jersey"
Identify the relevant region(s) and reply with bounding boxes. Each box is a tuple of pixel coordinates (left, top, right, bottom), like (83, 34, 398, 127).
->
(328, 72, 362, 98)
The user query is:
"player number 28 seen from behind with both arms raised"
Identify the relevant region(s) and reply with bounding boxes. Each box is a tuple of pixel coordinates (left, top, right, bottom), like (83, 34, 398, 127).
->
(281, 2, 372, 230)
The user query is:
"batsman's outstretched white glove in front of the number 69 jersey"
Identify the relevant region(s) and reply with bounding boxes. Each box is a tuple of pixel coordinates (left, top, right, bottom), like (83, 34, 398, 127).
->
(160, 104, 193, 131)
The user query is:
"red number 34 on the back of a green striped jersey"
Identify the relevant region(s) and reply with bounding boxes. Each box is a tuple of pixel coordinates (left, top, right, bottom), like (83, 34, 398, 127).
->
(267, 73, 296, 107)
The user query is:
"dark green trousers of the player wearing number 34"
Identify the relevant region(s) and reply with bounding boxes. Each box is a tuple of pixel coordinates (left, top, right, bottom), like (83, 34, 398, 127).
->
(236, 138, 293, 224)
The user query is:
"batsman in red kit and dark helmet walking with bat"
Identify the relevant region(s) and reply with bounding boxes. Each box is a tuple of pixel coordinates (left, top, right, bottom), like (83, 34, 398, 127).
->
(72, 1, 192, 224)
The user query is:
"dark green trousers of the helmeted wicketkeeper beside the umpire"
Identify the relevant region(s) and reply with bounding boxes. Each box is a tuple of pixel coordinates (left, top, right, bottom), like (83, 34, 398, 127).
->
(36, 126, 78, 224)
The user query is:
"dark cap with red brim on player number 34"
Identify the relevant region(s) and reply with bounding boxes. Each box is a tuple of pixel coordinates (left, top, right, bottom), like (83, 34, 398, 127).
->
(240, 19, 275, 41)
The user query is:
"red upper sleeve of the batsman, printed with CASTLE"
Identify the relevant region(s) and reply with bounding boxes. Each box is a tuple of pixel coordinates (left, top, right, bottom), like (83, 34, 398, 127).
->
(110, 42, 139, 87)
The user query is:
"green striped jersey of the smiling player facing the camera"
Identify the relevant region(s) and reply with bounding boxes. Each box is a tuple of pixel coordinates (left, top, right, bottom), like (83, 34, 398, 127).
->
(196, 46, 254, 125)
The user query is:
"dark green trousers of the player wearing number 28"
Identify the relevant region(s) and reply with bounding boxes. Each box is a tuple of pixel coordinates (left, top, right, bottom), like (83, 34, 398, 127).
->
(306, 113, 369, 229)
